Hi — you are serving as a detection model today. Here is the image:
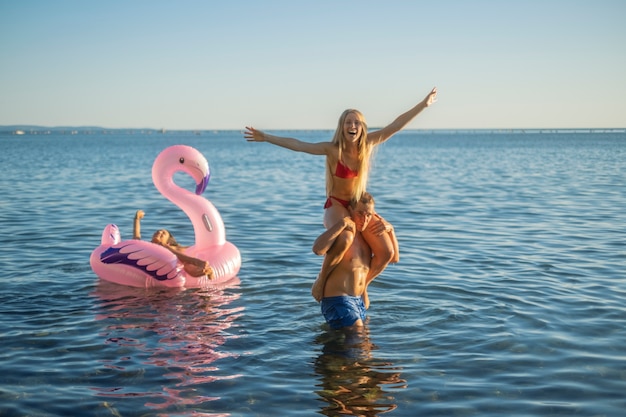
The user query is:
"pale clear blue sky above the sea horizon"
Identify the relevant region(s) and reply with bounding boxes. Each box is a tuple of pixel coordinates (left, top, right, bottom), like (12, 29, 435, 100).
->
(0, 0, 626, 129)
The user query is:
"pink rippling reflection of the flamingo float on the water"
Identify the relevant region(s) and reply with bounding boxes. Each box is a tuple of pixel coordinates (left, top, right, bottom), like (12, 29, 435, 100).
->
(92, 282, 243, 410)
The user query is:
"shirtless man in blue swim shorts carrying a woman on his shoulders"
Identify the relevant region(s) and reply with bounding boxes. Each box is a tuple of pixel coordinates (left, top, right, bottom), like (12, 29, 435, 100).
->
(312, 193, 399, 329)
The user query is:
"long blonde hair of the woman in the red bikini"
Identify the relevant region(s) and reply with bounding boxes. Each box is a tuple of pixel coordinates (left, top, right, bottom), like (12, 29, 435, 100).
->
(326, 109, 374, 200)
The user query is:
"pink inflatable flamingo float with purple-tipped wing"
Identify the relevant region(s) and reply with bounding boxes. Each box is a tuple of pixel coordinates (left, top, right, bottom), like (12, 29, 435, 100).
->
(89, 145, 241, 288)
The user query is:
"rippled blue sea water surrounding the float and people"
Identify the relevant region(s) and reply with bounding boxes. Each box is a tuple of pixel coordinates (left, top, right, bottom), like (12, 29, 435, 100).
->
(0, 131, 626, 417)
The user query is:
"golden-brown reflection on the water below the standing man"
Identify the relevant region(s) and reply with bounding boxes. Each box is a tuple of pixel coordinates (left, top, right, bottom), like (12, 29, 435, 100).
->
(315, 325, 406, 416)
